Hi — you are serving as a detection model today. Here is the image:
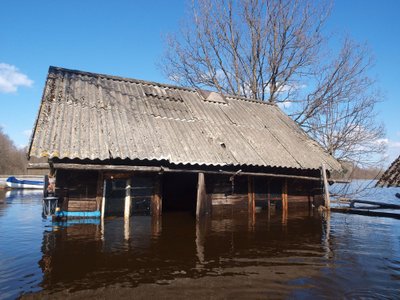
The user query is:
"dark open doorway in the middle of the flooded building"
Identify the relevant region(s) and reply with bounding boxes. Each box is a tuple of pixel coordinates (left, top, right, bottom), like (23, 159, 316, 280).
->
(162, 173, 197, 212)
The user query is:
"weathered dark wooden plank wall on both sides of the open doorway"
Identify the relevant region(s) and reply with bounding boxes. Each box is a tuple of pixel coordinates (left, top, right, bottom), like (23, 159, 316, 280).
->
(57, 170, 321, 215)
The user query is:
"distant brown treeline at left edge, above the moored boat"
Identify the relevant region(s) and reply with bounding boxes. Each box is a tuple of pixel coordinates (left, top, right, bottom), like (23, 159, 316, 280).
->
(0, 127, 28, 175)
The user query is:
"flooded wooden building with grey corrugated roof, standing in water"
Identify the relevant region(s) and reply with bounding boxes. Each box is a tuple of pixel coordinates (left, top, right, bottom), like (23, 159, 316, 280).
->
(29, 67, 341, 217)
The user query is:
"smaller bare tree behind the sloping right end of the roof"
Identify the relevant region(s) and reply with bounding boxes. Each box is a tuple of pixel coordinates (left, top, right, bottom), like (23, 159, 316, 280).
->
(292, 38, 386, 168)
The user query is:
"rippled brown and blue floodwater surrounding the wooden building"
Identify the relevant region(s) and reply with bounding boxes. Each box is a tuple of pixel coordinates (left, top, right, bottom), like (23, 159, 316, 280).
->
(0, 184, 400, 299)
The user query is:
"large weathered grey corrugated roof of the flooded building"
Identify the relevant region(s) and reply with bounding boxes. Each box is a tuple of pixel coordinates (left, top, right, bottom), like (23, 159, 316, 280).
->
(29, 67, 340, 170)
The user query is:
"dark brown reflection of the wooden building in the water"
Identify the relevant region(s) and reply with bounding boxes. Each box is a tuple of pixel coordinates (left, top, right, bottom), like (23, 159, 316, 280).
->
(39, 213, 325, 291)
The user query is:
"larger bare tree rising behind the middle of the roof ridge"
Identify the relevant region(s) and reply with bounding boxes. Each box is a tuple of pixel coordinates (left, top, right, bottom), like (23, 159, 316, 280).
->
(164, 0, 327, 102)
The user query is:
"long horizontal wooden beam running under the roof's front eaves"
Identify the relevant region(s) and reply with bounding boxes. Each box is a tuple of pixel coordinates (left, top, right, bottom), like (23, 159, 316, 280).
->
(53, 163, 321, 181)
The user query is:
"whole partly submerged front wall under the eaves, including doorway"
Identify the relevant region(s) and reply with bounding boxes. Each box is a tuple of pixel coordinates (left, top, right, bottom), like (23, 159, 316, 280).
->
(57, 170, 322, 216)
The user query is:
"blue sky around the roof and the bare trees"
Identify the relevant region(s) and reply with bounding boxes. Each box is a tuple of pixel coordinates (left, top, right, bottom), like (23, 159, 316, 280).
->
(0, 0, 400, 163)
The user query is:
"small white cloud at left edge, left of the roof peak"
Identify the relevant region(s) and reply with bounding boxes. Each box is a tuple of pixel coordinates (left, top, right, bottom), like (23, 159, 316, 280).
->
(0, 63, 33, 93)
